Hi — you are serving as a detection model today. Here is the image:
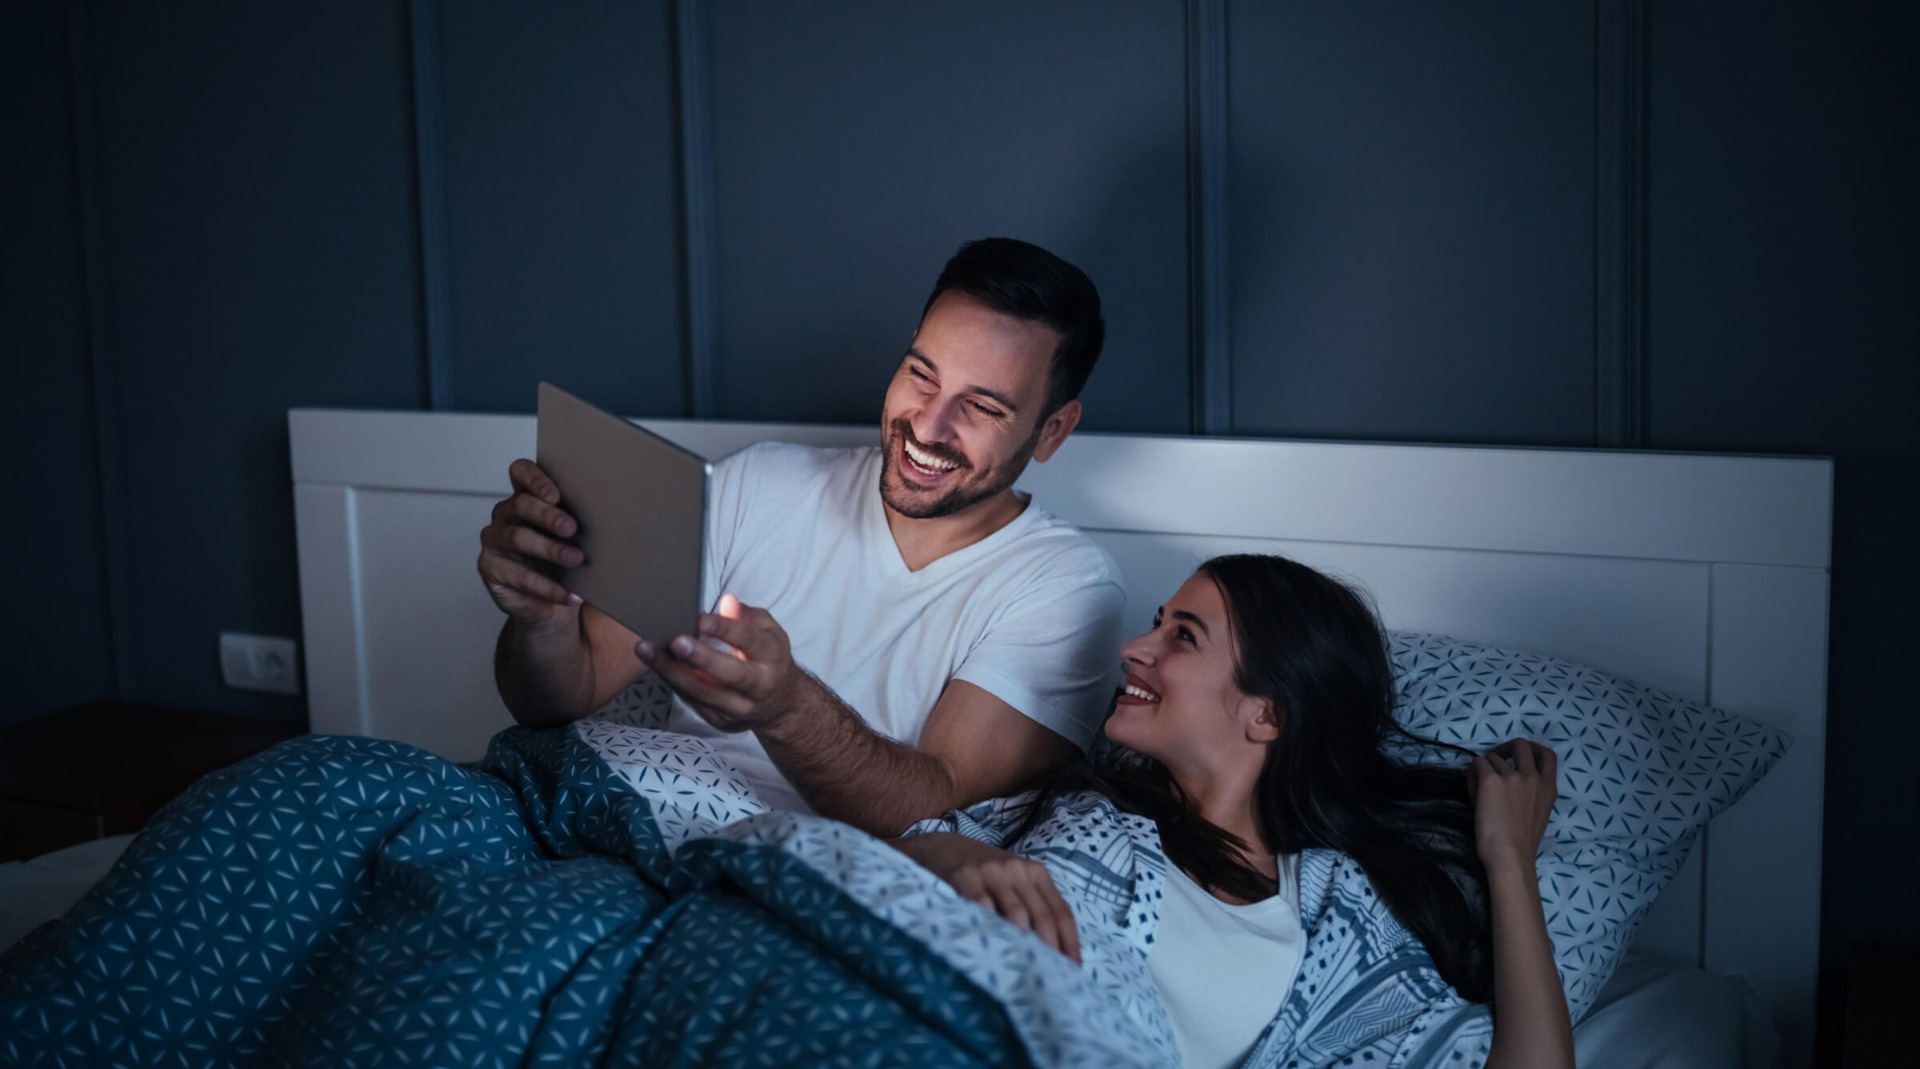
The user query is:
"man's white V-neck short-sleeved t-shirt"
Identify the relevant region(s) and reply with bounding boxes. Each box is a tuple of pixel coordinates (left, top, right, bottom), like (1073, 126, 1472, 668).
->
(668, 443, 1125, 812)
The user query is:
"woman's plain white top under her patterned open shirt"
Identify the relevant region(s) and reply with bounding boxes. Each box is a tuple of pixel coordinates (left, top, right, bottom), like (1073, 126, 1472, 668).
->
(1146, 858, 1306, 1069)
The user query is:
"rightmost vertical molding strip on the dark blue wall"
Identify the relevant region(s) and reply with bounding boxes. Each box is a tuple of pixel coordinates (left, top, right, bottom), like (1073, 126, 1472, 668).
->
(1594, 0, 1649, 449)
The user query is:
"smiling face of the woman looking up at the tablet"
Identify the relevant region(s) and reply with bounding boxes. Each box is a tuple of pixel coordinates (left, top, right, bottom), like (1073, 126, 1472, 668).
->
(1106, 574, 1273, 777)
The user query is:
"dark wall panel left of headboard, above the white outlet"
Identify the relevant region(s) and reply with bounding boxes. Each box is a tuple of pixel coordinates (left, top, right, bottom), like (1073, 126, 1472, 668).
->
(92, 0, 420, 710)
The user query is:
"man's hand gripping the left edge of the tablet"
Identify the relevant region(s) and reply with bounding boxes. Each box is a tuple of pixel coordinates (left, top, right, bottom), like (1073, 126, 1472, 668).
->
(480, 459, 586, 630)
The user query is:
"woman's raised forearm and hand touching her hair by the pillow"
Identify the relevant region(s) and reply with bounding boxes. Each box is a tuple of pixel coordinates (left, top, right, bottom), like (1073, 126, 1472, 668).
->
(1467, 739, 1572, 1069)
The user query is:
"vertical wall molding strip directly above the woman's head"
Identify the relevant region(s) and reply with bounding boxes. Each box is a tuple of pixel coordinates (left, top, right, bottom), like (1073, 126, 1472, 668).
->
(1187, 0, 1233, 434)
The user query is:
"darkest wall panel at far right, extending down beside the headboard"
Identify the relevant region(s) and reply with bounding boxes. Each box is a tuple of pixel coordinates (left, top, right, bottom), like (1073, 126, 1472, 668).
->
(1647, 2, 1920, 967)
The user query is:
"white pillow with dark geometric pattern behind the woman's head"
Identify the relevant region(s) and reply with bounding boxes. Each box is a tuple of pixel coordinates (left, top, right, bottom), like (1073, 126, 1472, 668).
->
(1388, 631, 1791, 1021)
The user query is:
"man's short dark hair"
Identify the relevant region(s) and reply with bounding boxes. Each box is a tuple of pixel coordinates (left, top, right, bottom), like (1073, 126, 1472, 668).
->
(920, 238, 1106, 418)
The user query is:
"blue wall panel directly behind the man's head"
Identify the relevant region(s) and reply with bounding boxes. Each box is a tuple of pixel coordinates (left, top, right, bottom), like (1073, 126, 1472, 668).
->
(708, 0, 1188, 430)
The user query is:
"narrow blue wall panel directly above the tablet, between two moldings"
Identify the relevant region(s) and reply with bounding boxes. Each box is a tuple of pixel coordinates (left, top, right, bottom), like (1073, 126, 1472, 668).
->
(439, 0, 685, 416)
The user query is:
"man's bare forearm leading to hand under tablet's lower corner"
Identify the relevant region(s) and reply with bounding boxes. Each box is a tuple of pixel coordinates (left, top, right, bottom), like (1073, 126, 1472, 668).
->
(755, 676, 962, 839)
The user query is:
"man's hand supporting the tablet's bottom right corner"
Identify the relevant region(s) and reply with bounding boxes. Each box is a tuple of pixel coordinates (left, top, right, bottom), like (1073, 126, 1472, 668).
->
(634, 595, 820, 731)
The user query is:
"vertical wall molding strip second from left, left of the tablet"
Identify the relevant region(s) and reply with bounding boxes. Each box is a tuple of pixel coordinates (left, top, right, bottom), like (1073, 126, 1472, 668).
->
(407, 0, 453, 413)
